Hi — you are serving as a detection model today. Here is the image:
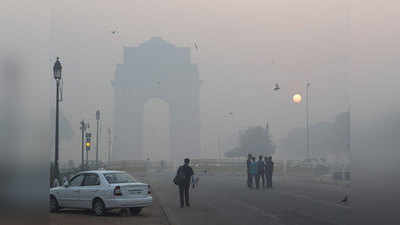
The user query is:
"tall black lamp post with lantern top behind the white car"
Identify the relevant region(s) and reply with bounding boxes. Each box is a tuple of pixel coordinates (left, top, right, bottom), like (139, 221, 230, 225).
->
(53, 57, 62, 179)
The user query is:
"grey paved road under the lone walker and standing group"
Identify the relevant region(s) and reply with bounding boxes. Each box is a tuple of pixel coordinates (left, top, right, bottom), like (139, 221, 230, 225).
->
(149, 174, 351, 225)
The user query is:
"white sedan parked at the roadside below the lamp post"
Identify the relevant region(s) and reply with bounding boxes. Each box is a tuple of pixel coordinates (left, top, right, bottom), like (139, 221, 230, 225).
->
(50, 170, 153, 216)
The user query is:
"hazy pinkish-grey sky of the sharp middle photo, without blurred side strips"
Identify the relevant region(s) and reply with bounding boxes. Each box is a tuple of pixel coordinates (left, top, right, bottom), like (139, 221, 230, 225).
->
(47, 0, 349, 162)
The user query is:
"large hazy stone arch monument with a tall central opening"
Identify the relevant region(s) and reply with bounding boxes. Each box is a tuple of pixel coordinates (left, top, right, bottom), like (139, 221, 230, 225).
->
(112, 37, 200, 163)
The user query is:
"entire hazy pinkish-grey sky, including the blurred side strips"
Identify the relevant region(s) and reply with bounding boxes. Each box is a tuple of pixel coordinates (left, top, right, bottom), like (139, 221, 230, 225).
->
(1, 0, 399, 162)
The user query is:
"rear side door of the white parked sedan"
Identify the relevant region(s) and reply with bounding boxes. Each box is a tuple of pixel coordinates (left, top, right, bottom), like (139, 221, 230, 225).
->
(80, 173, 101, 209)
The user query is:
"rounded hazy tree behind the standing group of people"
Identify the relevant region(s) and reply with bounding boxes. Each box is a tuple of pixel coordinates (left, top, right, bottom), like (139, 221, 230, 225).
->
(225, 124, 276, 157)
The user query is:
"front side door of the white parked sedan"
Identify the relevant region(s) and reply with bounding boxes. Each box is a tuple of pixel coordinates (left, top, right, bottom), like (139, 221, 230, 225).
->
(63, 174, 85, 208)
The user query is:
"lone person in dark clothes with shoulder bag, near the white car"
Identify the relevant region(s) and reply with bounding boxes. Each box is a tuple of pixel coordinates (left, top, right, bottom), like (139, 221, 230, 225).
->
(174, 158, 194, 208)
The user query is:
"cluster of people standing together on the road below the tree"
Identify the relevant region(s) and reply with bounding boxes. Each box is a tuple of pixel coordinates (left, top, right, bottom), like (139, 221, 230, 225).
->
(247, 154, 274, 189)
